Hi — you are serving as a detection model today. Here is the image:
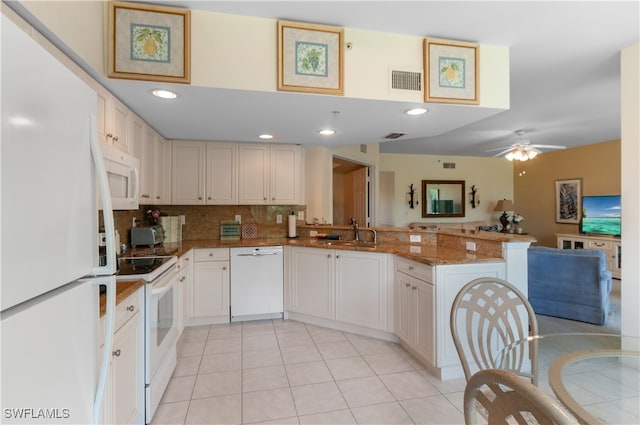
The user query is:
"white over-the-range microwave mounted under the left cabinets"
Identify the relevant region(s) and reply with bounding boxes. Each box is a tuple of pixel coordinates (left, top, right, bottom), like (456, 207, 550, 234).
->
(100, 145, 140, 210)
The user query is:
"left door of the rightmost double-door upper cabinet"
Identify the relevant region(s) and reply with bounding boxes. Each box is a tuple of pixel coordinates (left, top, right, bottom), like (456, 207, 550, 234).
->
(238, 144, 269, 205)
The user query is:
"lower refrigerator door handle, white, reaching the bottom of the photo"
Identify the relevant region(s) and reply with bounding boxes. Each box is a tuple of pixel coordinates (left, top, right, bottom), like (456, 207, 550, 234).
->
(91, 276, 116, 424)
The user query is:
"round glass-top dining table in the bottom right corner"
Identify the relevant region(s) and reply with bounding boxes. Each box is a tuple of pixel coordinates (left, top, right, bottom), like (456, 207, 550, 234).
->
(495, 333, 640, 425)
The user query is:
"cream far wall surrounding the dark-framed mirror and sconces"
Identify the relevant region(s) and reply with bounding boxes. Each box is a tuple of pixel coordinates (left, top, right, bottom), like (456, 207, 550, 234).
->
(380, 154, 513, 227)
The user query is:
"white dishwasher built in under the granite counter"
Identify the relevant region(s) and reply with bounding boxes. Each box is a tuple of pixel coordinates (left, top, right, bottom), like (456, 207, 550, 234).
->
(230, 246, 284, 322)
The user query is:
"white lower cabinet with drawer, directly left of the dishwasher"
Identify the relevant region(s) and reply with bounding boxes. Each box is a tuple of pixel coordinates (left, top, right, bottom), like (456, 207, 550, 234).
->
(188, 248, 230, 325)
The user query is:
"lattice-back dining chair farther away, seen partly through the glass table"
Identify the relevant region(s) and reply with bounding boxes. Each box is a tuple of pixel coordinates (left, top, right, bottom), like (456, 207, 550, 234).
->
(450, 277, 538, 385)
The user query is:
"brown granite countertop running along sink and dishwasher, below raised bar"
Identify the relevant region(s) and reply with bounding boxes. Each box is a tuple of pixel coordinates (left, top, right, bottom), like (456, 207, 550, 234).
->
(128, 238, 504, 265)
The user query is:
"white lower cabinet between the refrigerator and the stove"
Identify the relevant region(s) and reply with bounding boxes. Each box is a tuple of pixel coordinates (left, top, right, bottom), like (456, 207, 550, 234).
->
(98, 287, 145, 424)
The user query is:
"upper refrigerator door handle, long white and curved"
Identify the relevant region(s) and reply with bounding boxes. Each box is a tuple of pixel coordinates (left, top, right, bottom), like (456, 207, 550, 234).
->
(89, 114, 116, 276)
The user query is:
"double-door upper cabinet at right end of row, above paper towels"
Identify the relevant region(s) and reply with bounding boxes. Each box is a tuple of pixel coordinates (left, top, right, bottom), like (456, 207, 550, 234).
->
(238, 143, 301, 205)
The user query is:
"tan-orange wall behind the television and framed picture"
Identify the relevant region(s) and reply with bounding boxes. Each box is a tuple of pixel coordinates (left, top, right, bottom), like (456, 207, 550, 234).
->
(513, 140, 621, 246)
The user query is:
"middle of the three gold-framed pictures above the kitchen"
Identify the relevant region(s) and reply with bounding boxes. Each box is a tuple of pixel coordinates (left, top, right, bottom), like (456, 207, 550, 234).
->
(278, 21, 344, 96)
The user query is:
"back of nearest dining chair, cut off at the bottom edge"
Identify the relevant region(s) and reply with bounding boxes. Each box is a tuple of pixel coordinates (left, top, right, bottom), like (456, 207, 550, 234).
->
(464, 369, 578, 425)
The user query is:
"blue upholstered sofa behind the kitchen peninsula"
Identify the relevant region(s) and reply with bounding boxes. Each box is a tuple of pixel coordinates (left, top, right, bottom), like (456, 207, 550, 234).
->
(528, 246, 611, 325)
